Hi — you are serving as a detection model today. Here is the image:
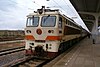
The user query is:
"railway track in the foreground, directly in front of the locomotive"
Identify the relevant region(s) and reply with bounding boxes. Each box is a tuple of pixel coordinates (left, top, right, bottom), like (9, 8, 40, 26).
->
(2, 56, 50, 67)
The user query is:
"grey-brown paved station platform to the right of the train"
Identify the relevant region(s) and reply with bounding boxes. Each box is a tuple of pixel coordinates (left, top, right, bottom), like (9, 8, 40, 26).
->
(44, 37, 100, 67)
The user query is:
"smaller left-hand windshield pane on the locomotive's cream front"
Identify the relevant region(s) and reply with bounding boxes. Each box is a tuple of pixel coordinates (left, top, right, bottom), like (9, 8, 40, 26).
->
(26, 16, 39, 27)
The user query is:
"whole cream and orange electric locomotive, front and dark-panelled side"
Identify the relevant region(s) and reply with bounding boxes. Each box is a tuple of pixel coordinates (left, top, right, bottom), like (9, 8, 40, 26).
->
(25, 6, 85, 57)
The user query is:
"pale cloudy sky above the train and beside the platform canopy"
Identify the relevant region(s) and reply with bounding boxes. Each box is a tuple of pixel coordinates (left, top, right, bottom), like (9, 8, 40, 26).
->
(0, 0, 88, 30)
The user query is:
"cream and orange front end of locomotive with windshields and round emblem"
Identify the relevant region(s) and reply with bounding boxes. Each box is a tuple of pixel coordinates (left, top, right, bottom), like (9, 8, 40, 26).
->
(25, 8, 61, 57)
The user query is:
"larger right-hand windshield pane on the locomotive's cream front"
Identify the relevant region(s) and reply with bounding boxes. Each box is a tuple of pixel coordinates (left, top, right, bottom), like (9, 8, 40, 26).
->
(41, 15, 56, 27)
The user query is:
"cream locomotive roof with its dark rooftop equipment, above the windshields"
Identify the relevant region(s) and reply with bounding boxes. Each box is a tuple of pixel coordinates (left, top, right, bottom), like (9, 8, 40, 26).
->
(28, 9, 80, 27)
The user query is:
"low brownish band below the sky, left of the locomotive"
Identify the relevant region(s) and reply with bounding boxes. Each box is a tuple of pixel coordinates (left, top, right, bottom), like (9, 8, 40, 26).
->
(0, 30, 25, 41)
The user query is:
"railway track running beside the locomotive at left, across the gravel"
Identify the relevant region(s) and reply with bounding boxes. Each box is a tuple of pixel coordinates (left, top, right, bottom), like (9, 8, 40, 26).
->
(0, 46, 25, 56)
